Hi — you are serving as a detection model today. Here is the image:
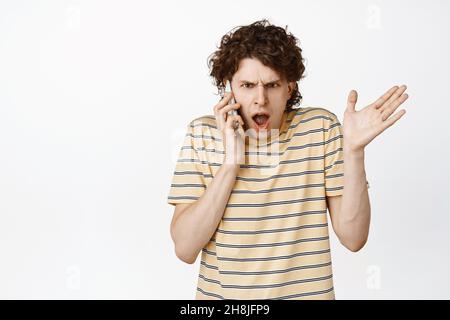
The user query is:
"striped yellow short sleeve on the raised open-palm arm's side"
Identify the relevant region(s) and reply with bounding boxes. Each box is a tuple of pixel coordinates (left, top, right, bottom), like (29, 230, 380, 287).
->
(324, 113, 344, 197)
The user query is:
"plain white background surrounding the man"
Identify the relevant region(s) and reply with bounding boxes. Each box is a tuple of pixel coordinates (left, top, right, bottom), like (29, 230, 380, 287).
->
(0, 0, 450, 299)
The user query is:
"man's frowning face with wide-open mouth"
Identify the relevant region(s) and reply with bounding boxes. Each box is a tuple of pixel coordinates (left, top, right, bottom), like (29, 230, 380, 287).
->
(231, 58, 295, 135)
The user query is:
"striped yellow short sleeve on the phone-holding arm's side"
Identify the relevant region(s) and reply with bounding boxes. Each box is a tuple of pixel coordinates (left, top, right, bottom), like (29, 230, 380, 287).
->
(167, 123, 206, 205)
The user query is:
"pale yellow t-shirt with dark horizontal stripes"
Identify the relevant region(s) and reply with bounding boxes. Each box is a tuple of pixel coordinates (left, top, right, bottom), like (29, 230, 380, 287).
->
(168, 107, 344, 300)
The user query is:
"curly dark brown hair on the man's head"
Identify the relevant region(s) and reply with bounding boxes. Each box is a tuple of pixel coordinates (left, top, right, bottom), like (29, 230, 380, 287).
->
(207, 19, 305, 110)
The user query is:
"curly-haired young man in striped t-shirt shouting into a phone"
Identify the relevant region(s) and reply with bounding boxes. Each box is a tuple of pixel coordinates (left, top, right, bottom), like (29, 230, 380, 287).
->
(168, 20, 407, 299)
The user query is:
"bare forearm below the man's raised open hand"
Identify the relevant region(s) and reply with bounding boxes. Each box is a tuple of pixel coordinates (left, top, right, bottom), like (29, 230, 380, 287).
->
(337, 147, 370, 251)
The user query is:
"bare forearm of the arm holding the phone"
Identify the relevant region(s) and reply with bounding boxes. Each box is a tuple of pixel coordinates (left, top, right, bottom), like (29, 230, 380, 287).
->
(173, 164, 238, 263)
